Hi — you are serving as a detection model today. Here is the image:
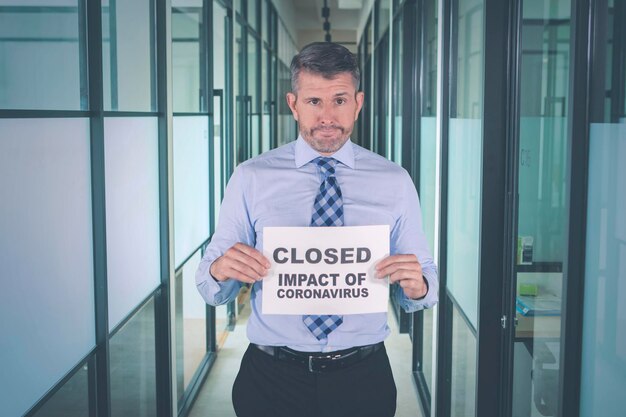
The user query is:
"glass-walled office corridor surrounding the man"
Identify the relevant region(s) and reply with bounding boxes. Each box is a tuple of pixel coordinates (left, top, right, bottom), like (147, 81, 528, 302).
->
(0, 0, 626, 417)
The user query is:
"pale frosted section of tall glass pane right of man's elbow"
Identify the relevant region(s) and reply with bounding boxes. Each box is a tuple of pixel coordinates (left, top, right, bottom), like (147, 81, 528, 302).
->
(447, 119, 482, 328)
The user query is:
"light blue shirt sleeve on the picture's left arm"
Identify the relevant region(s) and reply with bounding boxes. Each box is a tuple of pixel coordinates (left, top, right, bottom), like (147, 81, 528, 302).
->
(196, 165, 256, 306)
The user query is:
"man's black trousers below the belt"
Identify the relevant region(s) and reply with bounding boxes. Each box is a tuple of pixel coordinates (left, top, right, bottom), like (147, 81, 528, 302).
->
(233, 346, 396, 417)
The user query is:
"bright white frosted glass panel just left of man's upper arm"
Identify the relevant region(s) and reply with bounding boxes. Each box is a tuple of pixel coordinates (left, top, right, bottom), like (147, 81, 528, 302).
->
(174, 116, 211, 268)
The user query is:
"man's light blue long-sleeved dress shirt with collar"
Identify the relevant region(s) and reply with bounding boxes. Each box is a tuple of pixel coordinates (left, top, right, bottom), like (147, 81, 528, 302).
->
(196, 137, 439, 352)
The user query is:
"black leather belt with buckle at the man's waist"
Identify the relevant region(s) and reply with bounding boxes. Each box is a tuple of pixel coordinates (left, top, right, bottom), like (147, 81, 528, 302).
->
(251, 342, 384, 373)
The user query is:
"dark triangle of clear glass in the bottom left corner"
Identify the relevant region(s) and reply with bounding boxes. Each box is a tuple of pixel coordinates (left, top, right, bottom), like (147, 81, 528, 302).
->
(32, 364, 89, 417)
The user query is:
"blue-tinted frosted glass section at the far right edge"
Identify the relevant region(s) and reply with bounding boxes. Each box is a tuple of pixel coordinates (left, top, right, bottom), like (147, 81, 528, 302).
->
(580, 123, 626, 417)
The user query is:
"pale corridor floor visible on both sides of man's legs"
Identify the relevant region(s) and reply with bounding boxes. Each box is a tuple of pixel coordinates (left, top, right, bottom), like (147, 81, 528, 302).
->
(189, 302, 422, 417)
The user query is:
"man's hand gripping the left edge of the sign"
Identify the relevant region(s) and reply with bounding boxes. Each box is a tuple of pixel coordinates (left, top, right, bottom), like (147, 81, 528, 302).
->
(210, 243, 271, 284)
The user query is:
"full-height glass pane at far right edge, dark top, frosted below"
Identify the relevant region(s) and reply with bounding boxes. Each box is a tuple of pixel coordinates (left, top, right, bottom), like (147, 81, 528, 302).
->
(580, 0, 626, 417)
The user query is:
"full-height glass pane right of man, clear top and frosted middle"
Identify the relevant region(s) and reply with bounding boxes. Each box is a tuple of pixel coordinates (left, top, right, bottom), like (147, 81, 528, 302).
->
(446, 0, 484, 417)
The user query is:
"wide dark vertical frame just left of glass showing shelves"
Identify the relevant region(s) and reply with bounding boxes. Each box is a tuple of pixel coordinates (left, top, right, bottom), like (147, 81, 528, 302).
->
(476, 0, 517, 417)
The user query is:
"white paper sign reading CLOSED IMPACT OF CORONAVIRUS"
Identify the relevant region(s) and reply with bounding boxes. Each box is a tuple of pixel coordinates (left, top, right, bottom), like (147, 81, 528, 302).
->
(263, 225, 389, 315)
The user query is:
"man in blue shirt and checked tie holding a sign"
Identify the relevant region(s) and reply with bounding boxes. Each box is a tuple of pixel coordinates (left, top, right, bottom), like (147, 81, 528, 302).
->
(196, 43, 438, 417)
